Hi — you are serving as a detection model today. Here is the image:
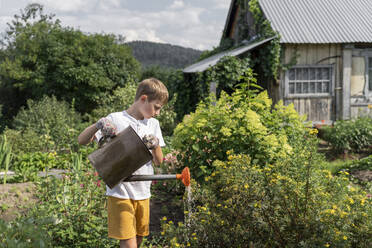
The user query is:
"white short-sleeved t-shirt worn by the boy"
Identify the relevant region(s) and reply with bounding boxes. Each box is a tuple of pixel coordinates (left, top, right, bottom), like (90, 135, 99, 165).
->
(95, 111, 165, 200)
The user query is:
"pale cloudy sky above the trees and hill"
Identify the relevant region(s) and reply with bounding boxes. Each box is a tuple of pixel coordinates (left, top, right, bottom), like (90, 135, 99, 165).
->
(0, 0, 230, 50)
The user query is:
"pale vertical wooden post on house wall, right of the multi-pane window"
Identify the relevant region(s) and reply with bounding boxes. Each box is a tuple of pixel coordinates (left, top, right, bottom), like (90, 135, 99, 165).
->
(342, 46, 352, 120)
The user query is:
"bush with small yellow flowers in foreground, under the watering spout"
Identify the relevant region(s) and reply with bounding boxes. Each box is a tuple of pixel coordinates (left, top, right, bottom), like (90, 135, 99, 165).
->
(163, 154, 372, 247)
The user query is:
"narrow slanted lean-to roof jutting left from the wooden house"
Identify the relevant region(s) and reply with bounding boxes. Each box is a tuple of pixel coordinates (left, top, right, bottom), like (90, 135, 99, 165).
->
(183, 37, 275, 73)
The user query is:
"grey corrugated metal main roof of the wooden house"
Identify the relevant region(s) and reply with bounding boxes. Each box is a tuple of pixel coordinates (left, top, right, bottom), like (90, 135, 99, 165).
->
(259, 0, 372, 43)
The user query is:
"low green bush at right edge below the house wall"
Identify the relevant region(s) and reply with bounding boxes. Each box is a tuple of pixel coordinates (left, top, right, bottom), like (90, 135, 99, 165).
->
(322, 117, 372, 152)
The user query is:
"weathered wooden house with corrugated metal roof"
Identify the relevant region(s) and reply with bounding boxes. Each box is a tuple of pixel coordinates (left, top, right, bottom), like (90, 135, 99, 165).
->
(184, 0, 372, 124)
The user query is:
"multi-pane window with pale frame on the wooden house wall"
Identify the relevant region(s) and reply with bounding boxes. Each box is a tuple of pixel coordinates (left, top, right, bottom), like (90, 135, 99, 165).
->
(287, 66, 332, 96)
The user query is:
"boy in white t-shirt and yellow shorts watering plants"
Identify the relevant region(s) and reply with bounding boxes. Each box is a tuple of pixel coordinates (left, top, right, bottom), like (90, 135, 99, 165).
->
(78, 78, 168, 248)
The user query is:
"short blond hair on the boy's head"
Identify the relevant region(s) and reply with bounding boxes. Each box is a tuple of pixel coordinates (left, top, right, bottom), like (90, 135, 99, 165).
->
(135, 78, 169, 105)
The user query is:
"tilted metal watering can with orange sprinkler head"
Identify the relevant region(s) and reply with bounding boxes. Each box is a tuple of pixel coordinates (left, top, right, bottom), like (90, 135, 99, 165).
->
(88, 126, 190, 189)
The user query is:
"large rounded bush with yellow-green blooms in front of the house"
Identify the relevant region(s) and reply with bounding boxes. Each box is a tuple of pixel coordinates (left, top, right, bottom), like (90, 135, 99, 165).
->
(173, 74, 307, 182)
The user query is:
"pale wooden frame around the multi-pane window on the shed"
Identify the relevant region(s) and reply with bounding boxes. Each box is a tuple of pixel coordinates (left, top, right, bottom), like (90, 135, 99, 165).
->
(284, 64, 335, 98)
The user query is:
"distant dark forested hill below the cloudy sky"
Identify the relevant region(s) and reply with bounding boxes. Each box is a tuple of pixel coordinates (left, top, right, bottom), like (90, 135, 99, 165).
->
(126, 41, 202, 69)
